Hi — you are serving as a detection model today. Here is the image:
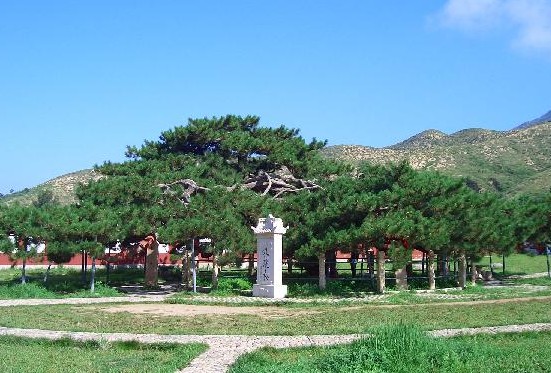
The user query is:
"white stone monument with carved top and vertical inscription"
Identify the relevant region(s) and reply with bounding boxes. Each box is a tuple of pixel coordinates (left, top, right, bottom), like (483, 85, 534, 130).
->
(251, 214, 288, 298)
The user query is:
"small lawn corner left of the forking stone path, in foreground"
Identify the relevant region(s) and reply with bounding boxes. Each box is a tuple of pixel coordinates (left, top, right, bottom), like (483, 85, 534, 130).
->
(0, 336, 206, 373)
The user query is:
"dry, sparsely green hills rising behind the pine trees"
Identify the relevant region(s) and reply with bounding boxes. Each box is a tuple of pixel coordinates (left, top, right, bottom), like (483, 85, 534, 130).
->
(0, 111, 551, 203)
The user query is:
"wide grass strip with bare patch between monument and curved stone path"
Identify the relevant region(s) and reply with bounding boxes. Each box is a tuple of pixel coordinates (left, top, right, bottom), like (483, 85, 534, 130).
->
(0, 297, 551, 335)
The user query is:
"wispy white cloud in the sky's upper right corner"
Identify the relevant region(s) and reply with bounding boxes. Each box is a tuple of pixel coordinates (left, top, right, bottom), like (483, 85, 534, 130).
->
(437, 0, 551, 57)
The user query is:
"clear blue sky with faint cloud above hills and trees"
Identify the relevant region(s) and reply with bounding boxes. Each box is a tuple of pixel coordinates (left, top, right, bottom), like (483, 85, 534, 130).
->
(0, 0, 551, 193)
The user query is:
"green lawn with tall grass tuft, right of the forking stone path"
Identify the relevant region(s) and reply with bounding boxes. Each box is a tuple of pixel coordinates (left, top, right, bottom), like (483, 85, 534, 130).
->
(230, 325, 551, 373)
